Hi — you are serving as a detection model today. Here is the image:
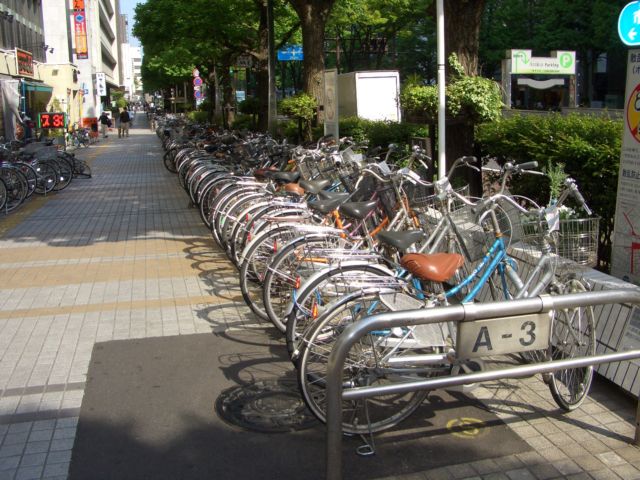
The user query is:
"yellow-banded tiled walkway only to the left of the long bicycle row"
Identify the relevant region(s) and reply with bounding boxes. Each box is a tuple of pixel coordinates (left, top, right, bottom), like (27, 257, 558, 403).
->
(0, 114, 251, 479)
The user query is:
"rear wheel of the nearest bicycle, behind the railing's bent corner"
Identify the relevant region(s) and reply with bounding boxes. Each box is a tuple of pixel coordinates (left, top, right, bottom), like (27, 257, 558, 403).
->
(297, 288, 428, 434)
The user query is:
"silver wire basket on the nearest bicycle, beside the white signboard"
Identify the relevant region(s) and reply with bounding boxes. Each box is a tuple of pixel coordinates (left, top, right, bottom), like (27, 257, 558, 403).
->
(558, 217, 600, 267)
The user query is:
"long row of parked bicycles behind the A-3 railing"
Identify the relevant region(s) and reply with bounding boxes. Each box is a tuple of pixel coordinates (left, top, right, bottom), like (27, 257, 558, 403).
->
(157, 119, 598, 435)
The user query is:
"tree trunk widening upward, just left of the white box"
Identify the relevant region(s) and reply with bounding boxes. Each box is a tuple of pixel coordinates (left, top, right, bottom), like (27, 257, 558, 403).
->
(289, 0, 335, 103)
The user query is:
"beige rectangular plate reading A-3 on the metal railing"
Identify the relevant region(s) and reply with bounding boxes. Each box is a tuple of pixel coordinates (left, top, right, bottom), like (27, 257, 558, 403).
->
(457, 313, 551, 359)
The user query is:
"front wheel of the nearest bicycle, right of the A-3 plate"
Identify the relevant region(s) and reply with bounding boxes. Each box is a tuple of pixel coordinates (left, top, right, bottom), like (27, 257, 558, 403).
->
(549, 278, 596, 411)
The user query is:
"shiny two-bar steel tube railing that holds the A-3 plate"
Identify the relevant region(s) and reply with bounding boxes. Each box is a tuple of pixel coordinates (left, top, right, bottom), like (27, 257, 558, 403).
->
(326, 289, 640, 480)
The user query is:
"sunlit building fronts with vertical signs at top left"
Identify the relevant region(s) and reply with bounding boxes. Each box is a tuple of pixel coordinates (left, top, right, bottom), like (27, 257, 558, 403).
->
(0, 0, 126, 138)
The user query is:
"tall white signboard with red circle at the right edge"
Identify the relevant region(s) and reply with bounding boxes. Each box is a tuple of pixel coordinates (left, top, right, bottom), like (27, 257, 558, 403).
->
(611, 50, 640, 285)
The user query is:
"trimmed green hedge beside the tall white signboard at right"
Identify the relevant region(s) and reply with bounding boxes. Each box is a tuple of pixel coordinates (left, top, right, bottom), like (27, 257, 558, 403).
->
(476, 114, 622, 268)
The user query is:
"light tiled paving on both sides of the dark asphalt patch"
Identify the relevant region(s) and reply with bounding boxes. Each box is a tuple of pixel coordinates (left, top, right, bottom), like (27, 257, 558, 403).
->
(0, 114, 640, 480)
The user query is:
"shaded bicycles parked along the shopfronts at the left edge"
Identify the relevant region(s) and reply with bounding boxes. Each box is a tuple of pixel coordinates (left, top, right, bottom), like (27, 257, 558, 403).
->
(0, 141, 91, 215)
